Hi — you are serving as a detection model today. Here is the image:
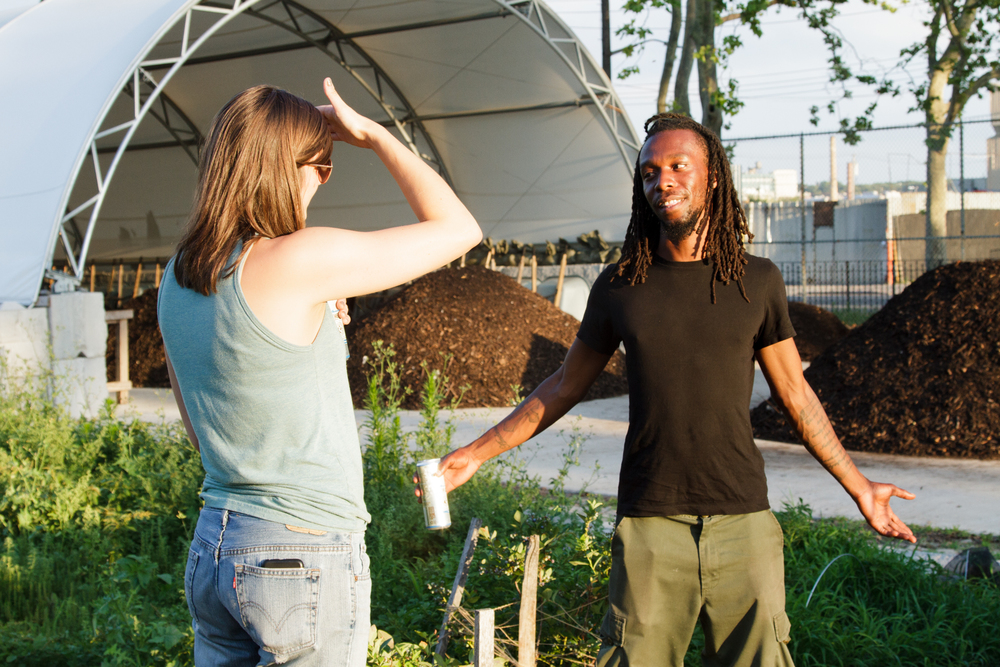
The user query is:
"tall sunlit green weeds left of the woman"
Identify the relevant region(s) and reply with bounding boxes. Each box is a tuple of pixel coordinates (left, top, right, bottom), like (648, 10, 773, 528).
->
(0, 368, 203, 665)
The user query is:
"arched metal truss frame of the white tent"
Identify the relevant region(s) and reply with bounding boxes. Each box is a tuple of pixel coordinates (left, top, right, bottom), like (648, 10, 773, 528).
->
(0, 0, 640, 301)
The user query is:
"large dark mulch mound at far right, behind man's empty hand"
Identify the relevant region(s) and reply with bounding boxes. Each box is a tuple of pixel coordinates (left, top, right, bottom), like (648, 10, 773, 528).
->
(751, 261, 1000, 459)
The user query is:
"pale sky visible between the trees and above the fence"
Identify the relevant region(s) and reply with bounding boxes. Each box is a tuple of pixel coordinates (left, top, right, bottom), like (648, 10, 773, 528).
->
(546, 0, 994, 183)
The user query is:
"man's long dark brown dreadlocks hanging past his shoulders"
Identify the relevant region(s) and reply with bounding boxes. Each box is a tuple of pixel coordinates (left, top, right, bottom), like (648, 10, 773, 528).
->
(612, 113, 753, 303)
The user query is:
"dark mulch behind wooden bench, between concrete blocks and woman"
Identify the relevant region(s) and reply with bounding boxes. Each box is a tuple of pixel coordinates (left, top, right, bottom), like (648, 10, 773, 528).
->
(106, 289, 170, 387)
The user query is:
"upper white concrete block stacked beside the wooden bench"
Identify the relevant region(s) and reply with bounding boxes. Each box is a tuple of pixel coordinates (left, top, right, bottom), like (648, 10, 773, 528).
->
(49, 292, 108, 360)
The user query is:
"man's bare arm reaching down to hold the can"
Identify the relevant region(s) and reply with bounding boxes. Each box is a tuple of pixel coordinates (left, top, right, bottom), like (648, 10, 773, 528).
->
(434, 338, 611, 495)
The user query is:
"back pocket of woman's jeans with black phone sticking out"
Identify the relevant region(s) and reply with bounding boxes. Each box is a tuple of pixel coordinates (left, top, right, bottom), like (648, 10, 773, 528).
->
(236, 565, 320, 662)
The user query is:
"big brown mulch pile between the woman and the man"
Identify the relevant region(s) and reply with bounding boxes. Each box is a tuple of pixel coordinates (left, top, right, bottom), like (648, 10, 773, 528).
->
(347, 267, 628, 409)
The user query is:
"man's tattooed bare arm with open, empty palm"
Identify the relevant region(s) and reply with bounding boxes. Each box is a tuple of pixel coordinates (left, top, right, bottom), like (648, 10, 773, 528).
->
(757, 338, 917, 542)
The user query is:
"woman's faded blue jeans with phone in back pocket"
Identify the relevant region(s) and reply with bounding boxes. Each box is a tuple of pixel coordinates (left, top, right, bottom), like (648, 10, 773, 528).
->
(184, 508, 371, 667)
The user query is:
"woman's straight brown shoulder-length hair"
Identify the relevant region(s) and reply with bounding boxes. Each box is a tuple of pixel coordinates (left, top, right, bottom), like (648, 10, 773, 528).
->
(174, 86, 333, 296)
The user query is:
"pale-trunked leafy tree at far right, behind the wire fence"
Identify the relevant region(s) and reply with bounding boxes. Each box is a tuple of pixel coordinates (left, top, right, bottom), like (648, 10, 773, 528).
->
(804, 0, 1000, 268)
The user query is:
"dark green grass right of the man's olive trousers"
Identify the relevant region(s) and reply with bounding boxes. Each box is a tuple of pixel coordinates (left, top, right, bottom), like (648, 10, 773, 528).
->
(779, 504, 1000, 667)
